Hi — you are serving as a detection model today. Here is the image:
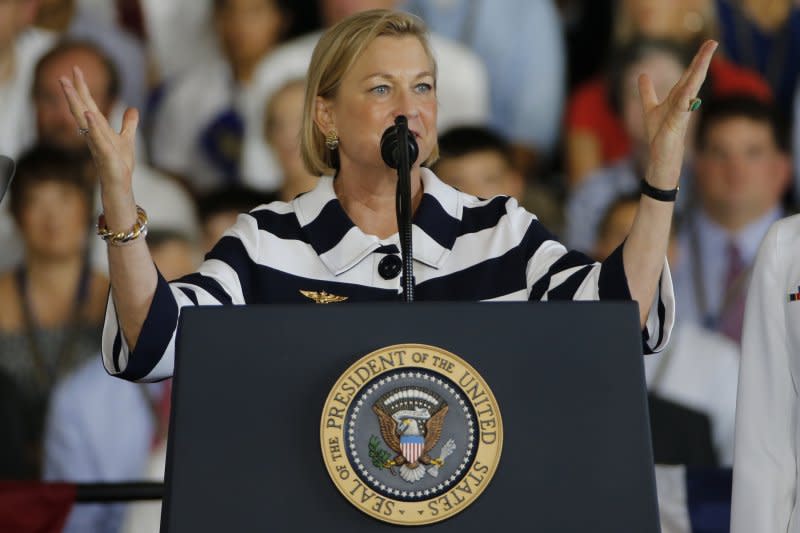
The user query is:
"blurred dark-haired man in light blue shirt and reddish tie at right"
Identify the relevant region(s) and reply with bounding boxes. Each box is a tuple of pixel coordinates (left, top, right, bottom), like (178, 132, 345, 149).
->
(674, 96, 791, 343)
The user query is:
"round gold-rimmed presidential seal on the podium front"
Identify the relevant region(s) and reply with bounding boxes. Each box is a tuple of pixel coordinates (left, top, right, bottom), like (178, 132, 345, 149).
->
(320, 344, 503, 526)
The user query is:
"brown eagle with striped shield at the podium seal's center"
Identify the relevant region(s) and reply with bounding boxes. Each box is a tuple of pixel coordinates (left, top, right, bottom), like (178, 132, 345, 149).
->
(372, 387, 455, 483)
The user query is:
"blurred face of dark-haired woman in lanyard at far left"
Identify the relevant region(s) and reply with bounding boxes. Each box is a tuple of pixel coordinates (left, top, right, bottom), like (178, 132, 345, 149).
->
(19, 181, 89, 259)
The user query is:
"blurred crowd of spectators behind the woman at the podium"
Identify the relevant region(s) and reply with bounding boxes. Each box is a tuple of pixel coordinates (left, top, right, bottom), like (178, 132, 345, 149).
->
(0, 0, 800, 532)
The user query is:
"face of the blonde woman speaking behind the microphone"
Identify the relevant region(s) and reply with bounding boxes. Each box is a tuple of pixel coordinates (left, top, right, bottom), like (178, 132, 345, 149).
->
(316, 36, 437, 177)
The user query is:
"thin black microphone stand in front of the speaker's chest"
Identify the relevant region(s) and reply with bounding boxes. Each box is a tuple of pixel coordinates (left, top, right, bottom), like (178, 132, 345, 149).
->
(395, 116, 415, 303)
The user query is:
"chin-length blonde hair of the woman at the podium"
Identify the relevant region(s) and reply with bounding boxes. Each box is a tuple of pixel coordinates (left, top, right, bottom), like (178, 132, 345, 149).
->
(300, 9, 439, 176)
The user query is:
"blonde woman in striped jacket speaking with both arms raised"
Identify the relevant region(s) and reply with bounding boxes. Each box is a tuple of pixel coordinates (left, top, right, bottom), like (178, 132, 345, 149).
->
(61, 10, 716, 381)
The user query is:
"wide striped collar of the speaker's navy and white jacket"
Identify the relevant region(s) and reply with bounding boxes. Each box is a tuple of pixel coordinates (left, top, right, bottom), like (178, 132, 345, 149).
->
(292, 168, 463, 276)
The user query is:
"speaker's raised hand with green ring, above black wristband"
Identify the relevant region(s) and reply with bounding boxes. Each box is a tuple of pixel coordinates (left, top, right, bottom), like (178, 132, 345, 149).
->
(639, 41, 717, 189)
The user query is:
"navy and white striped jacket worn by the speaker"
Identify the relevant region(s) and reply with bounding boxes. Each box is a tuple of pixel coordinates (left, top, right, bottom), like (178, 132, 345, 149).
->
(103, 169, 674, 381)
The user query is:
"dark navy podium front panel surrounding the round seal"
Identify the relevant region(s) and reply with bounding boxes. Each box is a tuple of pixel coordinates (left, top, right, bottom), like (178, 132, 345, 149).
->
(162, 302, 659, 533)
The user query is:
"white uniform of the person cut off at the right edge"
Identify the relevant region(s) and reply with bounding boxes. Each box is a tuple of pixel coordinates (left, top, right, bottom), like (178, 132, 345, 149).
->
(731, 215, 800, 533)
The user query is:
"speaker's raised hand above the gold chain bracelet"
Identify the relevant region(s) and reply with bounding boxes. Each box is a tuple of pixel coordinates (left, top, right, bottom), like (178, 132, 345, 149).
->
(59, 67, 139, 230)
